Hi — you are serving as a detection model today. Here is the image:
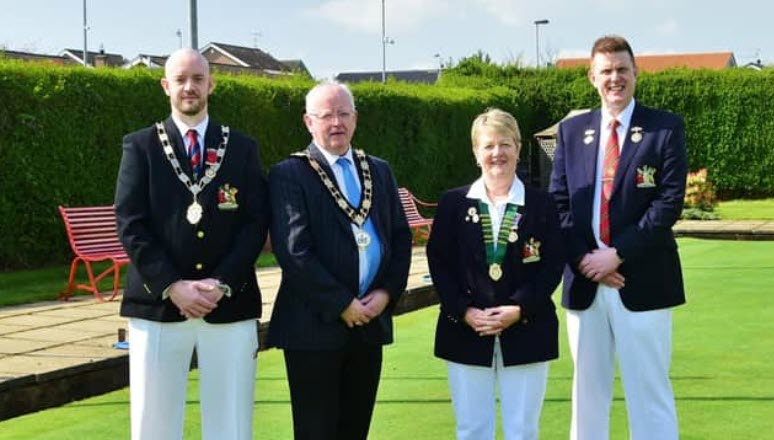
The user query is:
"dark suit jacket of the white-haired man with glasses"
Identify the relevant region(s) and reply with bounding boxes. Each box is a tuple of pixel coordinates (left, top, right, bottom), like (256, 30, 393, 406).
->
(269, 144, 411, 350)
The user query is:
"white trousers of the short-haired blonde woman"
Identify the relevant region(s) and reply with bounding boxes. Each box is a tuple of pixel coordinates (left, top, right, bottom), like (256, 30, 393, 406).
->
(446, 339, 548, 440)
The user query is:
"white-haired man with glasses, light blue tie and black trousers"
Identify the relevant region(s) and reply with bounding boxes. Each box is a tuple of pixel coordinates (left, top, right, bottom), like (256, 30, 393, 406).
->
(269, 82, 411, 440)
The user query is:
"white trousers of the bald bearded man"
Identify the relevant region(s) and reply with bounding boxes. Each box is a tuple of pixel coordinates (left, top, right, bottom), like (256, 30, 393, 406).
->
(129, 318, 258, 440)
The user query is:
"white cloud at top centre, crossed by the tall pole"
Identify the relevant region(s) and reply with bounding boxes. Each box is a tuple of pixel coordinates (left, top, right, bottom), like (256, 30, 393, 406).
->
(307, 0, 450, 35)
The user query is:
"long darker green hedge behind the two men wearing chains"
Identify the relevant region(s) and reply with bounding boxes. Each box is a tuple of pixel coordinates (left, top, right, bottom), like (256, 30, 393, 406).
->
(0, 62, 519, 269)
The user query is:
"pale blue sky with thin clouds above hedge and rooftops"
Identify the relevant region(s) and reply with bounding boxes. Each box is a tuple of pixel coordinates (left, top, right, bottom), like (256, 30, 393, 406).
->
(0, 0, 774, 79)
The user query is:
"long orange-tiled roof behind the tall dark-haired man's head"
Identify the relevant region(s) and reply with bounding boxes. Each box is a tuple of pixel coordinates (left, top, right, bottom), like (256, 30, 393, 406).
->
(556, 52, 736, 72)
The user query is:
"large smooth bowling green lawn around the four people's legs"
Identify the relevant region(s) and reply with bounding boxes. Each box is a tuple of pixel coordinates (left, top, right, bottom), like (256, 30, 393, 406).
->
(0, 239, 774, 440)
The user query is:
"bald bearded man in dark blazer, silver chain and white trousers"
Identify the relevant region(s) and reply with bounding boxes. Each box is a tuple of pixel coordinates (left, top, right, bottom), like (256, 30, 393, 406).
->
(115, 49, 268, 440)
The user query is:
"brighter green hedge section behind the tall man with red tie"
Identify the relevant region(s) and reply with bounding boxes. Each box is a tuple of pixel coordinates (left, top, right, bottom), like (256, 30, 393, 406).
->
(442, 65, 774, 198)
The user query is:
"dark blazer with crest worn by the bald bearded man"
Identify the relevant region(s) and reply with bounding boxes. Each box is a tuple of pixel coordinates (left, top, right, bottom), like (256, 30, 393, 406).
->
(115, 118, 269, 323)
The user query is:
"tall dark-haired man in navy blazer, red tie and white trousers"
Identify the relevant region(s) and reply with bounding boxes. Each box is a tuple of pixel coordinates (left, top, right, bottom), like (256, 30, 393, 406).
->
(550, 36, 687, 440)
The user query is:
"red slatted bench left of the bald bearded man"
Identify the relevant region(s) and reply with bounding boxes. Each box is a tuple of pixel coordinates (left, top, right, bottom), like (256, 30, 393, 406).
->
(59, 206, 129, 301)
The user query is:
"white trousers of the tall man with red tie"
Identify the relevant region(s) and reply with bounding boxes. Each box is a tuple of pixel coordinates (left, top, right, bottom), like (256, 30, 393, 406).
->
(567, 285, 678, 440)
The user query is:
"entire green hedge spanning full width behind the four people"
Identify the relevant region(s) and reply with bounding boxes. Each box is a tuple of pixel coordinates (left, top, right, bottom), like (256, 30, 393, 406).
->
(0, 60, 774, 269)
